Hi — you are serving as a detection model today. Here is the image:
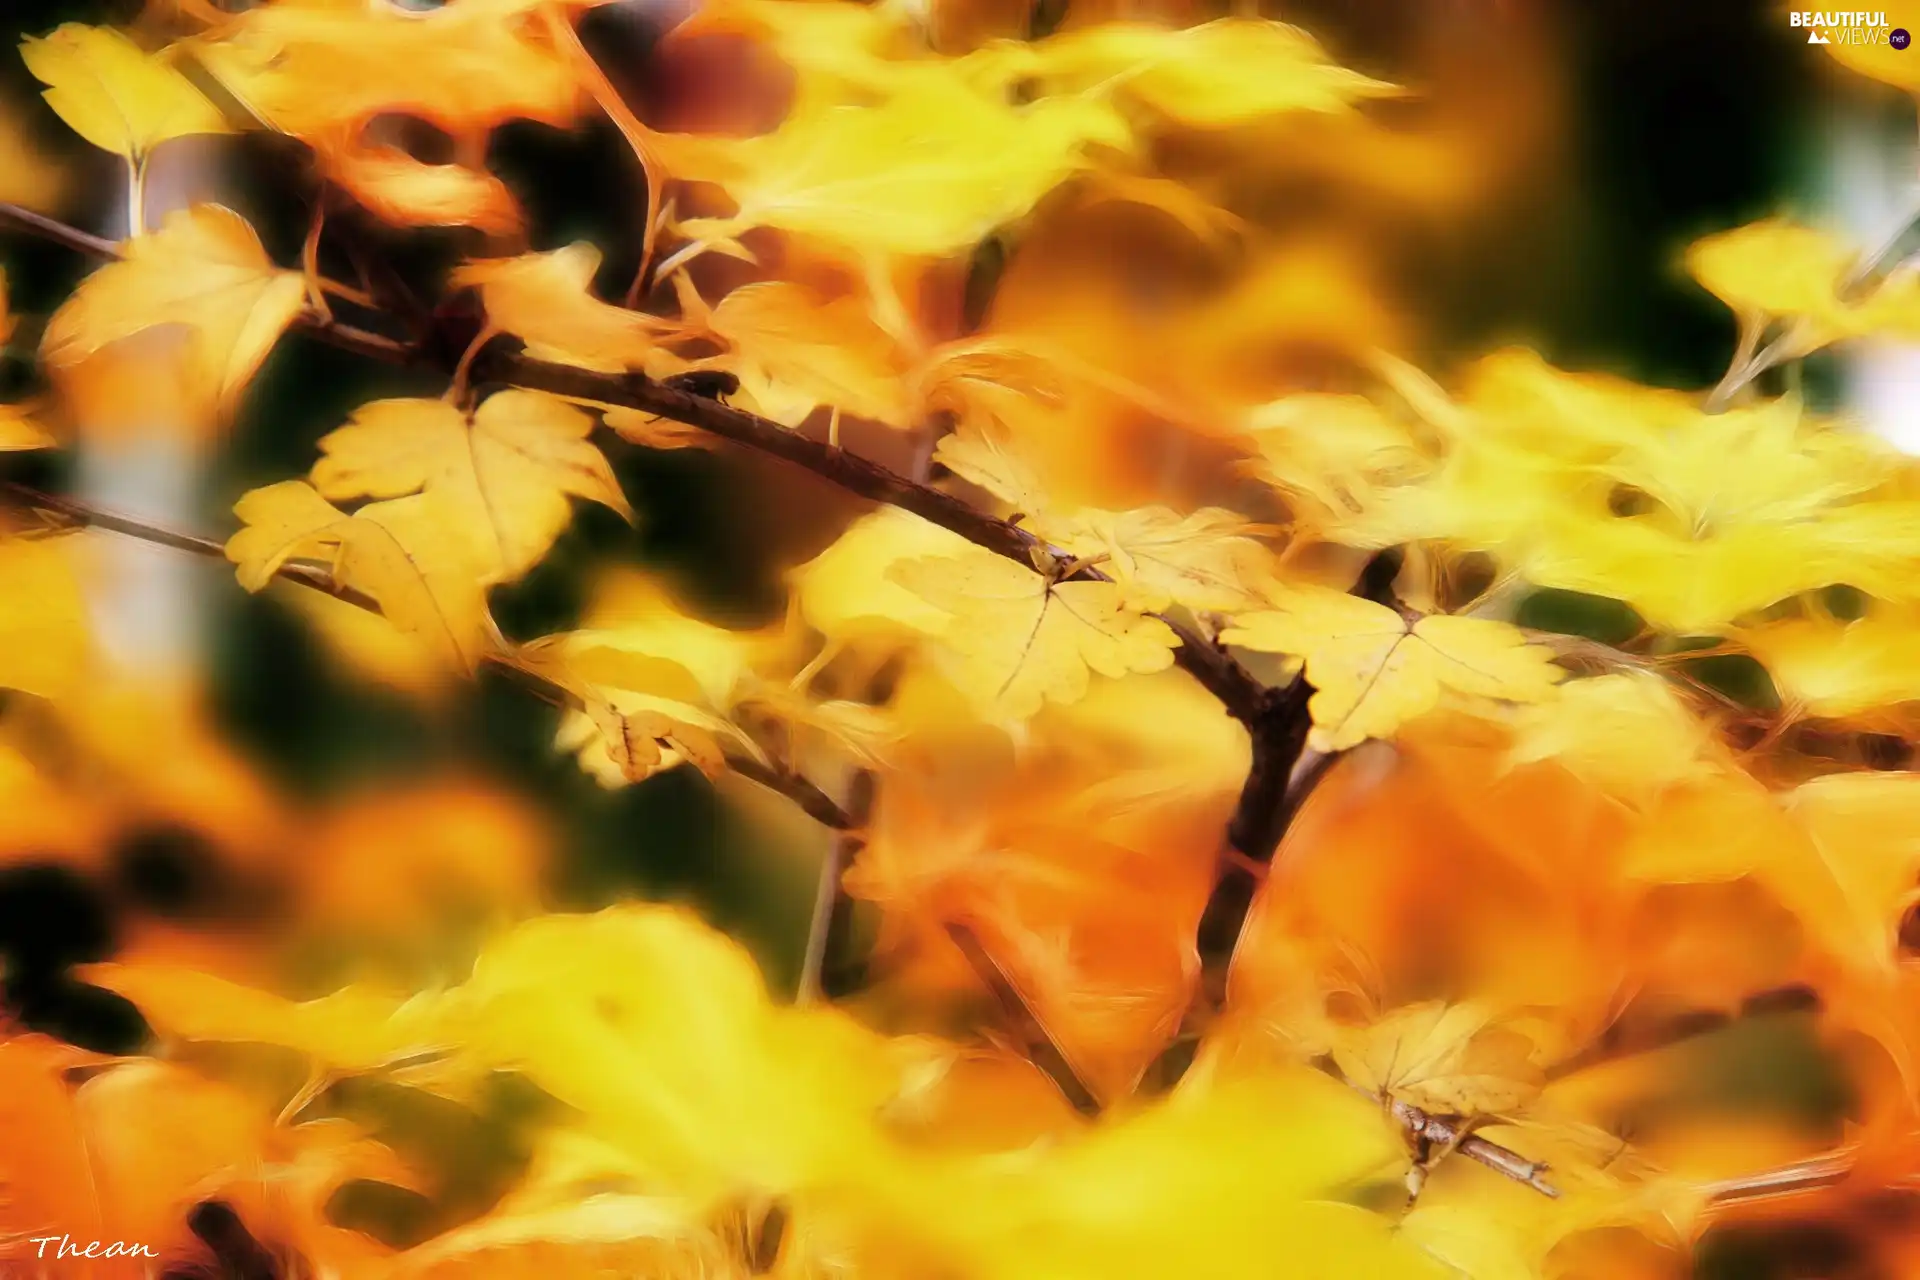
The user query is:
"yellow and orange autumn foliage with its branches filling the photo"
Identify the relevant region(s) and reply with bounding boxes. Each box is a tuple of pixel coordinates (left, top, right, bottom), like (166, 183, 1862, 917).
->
(0, 0, 1920, 1280)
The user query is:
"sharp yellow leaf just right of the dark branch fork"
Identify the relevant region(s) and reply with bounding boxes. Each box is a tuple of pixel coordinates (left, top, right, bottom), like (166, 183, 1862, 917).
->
(1219, 585, 1563, 752)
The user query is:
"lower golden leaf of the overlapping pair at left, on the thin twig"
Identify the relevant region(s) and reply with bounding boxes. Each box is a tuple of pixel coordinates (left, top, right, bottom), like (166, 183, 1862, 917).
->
(227, 480, 493, 670)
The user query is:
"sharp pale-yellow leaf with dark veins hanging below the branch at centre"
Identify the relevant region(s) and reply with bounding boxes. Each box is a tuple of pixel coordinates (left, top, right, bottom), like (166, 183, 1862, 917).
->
(887, 549, 1179, 720)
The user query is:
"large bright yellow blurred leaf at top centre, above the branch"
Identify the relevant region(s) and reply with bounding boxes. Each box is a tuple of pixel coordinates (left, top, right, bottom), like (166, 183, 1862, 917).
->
(674, 75, 1131, 257)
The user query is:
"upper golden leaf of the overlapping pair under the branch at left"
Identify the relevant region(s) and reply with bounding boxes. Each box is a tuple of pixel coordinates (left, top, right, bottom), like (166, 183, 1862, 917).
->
(313, 390, 634, 581)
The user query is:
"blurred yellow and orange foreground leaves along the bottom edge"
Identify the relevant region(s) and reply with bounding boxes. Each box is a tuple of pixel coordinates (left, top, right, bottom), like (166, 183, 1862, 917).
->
(15, 908, 1446, 1280)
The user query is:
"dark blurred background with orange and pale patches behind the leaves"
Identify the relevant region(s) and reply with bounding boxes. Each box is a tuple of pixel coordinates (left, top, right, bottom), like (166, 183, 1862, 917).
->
(0, 0, 1920, 1274)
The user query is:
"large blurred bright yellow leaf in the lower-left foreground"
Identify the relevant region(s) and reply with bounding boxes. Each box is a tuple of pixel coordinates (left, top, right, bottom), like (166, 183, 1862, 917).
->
(449, 906, 899, 1209)
